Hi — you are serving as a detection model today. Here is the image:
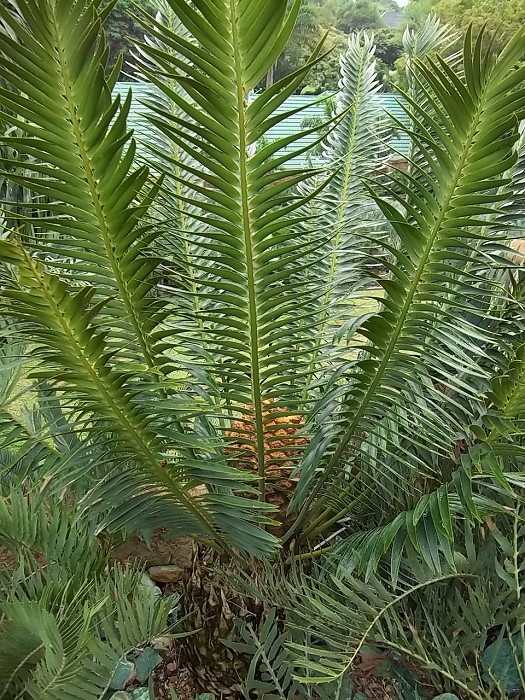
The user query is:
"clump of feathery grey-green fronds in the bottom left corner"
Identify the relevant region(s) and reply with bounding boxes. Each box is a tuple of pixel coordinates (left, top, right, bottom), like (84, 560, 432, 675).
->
(0, 488, 178, 700)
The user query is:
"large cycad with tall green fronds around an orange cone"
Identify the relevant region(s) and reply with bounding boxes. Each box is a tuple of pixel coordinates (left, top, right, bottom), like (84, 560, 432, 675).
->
(0, 0, 525, 700)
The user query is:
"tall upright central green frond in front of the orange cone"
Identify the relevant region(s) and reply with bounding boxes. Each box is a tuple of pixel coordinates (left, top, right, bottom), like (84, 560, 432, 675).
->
(133, 0, 334, 495)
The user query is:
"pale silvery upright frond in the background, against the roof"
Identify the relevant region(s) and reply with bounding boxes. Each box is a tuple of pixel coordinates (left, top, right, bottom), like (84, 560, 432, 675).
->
(321, 32, 387, 322)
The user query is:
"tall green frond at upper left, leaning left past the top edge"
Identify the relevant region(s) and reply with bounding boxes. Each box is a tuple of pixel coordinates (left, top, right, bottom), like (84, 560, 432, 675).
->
(0, 0, 163, 367)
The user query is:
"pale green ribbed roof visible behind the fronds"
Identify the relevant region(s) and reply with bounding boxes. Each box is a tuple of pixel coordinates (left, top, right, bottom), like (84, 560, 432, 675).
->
(115, 82, 410, 167)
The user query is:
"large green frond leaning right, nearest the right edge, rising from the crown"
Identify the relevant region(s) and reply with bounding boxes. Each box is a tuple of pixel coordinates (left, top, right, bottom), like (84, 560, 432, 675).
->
(288, 27, 525, 528)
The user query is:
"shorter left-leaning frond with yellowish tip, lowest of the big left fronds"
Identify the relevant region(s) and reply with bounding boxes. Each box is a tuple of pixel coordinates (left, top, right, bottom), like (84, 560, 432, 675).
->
(0, 241, 274, 553)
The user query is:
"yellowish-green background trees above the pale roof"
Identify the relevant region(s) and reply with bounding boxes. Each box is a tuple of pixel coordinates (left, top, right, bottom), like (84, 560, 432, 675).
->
(98, 0, 525, 93)
